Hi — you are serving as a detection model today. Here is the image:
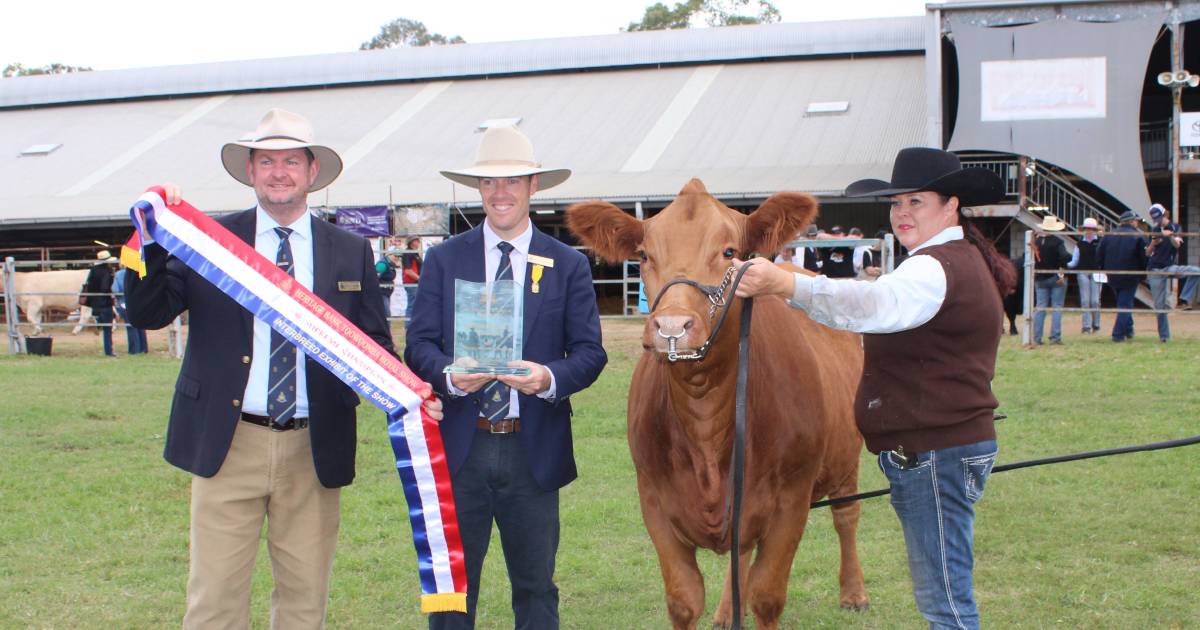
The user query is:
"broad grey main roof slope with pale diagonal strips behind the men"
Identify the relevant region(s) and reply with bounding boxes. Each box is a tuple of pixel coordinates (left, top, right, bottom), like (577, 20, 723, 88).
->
(0, 54, 925, 226)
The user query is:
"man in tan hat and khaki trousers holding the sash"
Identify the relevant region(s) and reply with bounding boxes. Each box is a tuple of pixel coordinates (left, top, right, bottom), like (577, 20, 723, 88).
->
(127, 109, 405, 629)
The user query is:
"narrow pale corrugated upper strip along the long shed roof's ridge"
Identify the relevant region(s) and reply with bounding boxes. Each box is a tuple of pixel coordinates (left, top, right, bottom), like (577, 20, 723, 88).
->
(0, 16, 925, 108)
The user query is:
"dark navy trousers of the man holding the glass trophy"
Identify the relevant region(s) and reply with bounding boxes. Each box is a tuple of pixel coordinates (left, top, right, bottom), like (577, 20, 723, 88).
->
(430, 431, 559, 630)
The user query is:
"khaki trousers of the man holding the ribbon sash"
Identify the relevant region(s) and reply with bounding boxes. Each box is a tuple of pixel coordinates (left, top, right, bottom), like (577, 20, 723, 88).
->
(184, 422, 341, 630)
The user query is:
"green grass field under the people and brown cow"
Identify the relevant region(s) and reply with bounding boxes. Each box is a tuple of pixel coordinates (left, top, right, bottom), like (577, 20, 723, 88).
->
(0, 314, 1200, 629)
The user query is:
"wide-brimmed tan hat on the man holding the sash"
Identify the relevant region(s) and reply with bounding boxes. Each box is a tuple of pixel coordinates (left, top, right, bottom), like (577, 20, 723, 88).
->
(221, 108, 342, 192)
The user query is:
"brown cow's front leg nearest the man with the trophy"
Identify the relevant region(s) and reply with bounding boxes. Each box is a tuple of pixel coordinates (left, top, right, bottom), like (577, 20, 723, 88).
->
(640, 488, 704, 630)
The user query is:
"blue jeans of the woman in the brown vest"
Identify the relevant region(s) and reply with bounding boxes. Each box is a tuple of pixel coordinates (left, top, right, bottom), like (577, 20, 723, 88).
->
(878, 439, 997, 629)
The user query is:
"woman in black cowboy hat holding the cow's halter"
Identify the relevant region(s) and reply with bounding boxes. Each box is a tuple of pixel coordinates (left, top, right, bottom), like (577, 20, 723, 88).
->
(734, 148, 1016, 628)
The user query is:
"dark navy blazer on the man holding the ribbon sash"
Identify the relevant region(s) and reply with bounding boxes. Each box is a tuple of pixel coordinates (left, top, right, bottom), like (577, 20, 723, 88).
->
(126, 209, 395, 487)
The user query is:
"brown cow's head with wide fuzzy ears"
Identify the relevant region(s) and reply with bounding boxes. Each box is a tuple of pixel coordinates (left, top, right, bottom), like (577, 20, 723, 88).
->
(566, 179, 817, 353)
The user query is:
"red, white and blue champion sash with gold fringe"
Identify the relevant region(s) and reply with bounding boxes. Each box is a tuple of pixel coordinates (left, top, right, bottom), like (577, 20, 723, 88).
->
(130, 187, 467, 612)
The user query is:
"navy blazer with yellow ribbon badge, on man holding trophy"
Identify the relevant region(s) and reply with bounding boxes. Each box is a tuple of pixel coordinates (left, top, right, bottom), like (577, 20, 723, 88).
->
(404, 224, 608, 491)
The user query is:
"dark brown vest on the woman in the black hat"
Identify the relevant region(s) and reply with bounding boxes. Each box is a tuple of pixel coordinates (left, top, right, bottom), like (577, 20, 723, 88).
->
(854, 239, 1004, 452)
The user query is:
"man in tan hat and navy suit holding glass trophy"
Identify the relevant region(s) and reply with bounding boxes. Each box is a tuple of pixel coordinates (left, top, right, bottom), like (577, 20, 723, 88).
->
(404, 127, 607, 630)
